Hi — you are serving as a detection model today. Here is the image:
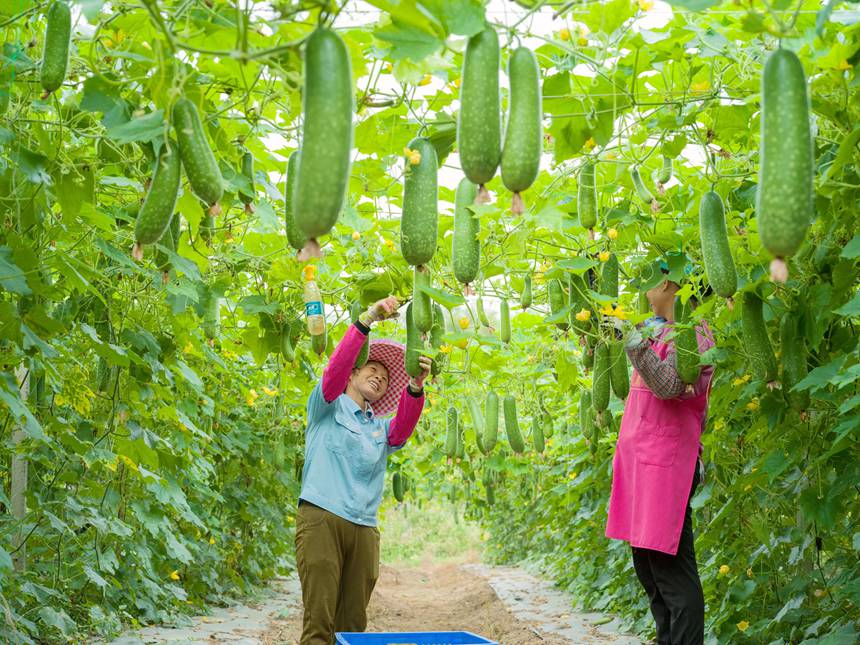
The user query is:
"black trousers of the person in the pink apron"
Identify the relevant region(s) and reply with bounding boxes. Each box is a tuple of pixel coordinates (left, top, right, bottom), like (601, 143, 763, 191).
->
(633, 464, 705, 645)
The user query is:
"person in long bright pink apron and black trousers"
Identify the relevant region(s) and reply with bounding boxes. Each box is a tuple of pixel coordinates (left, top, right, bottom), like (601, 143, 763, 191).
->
(606, 265, 713, 645)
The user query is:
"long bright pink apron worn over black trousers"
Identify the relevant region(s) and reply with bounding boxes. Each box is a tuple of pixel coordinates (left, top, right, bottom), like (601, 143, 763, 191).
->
(606, 325, 714, 555)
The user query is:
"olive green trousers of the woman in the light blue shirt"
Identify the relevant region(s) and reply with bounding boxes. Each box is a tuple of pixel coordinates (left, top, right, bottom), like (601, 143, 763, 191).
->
(296, 502, 379, 645)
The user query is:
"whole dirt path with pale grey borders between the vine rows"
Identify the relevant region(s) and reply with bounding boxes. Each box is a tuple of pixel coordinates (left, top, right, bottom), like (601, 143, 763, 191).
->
(111, 557, 640, 645)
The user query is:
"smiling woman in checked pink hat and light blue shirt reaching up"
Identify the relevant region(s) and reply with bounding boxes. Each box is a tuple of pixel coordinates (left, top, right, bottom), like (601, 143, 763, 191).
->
(296, 297, 431, 645)
